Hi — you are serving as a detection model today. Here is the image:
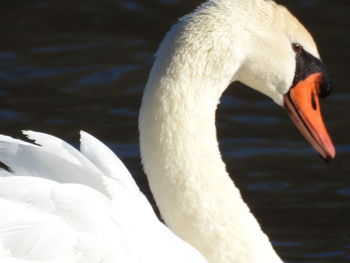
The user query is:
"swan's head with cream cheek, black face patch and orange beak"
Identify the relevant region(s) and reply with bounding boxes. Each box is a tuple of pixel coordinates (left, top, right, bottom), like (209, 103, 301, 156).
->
(230, 2, 335, 160)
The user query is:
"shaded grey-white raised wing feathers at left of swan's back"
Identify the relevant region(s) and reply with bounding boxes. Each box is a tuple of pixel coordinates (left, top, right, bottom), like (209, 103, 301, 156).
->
(0, 132, 109, 196)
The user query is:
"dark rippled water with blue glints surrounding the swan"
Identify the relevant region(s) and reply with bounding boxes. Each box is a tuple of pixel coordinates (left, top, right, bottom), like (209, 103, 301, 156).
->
(0, 0, 350, 263)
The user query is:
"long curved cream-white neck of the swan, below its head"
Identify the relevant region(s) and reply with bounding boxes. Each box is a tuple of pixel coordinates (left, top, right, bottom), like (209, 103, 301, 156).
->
(139, 1, 281, 263)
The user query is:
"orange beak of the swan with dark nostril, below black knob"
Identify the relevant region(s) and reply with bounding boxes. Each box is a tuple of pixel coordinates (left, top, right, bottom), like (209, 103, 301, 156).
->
(284, 73, 335, 160)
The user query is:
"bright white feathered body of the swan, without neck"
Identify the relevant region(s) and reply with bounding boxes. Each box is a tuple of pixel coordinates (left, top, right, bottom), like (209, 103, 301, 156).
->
(0, 131, 206, 263)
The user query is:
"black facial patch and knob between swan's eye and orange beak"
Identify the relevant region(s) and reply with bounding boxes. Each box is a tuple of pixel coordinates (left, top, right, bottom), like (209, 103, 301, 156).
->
(292, 46, 331, 98)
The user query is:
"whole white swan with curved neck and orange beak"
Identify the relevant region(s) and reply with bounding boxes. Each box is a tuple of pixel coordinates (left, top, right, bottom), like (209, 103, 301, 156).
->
(0, 0, 335, 263)
